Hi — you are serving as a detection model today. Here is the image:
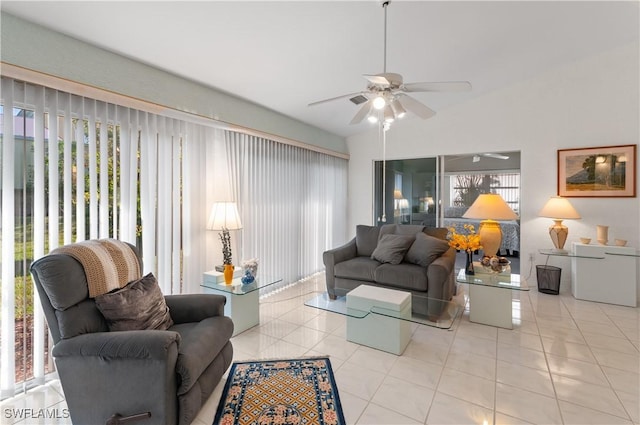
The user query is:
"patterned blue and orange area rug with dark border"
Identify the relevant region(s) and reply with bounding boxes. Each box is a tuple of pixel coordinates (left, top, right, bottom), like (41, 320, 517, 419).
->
(213, 357, 346, 425)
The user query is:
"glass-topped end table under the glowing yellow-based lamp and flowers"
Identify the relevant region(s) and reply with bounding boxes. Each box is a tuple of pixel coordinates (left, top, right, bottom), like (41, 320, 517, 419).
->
(456, 269, 529, 329)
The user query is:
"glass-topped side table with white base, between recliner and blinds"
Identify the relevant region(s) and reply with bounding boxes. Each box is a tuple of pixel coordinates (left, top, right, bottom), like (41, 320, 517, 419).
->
(200, 275, 282, 336)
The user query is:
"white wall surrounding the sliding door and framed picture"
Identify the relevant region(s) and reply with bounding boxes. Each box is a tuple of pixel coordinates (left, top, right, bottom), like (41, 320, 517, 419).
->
(347, 43, 640, 293)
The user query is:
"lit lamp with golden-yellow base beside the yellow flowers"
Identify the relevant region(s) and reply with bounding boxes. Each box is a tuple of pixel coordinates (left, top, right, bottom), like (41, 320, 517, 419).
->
(462, 193, 518, 257)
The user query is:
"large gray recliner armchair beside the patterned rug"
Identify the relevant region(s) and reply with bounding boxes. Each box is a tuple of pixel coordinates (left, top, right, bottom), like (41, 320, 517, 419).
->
(31, 240, 233, 425)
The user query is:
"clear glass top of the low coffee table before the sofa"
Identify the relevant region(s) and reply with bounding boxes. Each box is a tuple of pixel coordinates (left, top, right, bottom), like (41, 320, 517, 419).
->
(304, 292, 462, 329)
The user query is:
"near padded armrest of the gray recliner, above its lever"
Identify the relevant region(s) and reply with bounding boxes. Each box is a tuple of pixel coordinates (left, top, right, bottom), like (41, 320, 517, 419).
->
(52, 330, 180, 360)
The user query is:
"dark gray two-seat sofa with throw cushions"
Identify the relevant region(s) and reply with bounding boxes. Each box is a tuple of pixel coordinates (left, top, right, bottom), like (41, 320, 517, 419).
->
(323, 224, 456, 319)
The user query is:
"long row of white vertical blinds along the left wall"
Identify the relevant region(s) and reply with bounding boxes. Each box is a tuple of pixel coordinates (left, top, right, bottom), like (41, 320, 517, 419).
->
(0, 77, 347, 399)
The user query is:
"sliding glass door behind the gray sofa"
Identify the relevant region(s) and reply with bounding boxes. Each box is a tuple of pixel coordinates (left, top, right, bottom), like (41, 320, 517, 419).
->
(374, 152, 520, 256)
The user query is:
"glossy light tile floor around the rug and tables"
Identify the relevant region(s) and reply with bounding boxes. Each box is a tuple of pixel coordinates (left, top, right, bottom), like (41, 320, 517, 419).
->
(2, 275, 640, 425)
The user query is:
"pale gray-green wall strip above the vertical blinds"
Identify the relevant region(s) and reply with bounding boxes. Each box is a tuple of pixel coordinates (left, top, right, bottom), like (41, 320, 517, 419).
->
(0, 12, 346, 153)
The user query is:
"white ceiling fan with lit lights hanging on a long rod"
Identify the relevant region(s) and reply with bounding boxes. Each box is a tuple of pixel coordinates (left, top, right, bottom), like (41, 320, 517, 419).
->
(308, 0, 471, 124)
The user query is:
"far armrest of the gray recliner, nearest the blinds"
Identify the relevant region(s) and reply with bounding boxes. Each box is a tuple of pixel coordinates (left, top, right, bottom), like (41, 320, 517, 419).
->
(164, 294, 227, 324)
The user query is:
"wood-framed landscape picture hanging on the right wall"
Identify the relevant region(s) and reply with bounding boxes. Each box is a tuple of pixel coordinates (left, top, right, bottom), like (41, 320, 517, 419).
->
(558, 145, 637, 198)
